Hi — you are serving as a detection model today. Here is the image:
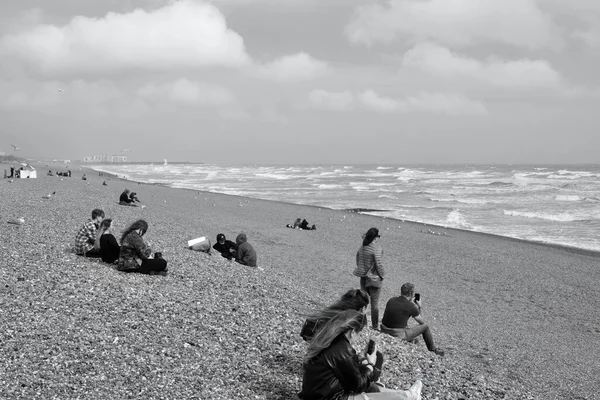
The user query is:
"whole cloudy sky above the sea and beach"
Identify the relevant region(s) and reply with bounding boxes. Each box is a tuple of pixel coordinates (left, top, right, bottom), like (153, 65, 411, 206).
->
(0, 0, 600, 164)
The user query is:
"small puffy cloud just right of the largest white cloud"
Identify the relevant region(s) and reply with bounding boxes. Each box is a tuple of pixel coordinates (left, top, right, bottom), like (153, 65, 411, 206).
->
(258, 52, 329, 82)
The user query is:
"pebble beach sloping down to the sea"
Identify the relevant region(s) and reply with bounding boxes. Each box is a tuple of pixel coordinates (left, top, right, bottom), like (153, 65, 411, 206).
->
(0, 164, 600, 399)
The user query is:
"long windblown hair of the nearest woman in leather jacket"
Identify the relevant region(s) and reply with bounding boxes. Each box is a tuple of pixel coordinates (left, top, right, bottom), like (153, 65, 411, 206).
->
(304, 310, 367, 364)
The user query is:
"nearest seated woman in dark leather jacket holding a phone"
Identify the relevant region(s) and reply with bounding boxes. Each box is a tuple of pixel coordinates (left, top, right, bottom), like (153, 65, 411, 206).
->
(298, 310, 422, 400)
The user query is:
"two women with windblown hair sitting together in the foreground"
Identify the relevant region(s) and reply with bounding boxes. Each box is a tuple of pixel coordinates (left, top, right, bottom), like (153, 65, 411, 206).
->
(298, 289, 422, 400)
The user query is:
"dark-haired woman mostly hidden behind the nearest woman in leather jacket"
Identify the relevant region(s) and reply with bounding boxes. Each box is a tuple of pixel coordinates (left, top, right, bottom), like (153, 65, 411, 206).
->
(300, 289, 369, 341)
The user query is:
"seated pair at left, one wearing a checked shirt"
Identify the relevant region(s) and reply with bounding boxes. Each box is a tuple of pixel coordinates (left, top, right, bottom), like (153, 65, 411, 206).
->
(75, 209, 167, 275)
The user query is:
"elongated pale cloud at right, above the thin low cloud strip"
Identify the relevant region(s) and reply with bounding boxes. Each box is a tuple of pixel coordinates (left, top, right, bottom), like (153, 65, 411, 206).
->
(402, 43, 561, 89)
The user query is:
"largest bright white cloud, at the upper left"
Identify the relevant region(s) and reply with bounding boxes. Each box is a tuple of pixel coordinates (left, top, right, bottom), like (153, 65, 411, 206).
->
(0, 0, 249, 75)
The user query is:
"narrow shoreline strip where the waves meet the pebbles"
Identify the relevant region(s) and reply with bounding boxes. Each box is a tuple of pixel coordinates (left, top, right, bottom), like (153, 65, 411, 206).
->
(82, 166, 600, 257)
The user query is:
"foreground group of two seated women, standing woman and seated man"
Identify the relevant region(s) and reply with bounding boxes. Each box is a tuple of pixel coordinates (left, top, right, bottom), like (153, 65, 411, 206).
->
(298, 228, 444, 400)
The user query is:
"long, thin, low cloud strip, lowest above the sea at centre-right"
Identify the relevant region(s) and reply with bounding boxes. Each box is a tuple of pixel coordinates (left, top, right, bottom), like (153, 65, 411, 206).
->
(309, 89, 488, 116)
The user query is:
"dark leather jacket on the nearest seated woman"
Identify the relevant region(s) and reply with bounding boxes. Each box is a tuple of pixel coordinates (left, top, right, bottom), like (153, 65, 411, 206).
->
(299, 334, 372, 400)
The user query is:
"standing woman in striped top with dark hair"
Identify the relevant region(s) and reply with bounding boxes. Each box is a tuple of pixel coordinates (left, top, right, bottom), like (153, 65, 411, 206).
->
(353, 228, 385, 330)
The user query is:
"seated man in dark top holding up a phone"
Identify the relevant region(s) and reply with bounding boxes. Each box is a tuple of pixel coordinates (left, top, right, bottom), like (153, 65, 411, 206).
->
(381, 283, 444, 356)
